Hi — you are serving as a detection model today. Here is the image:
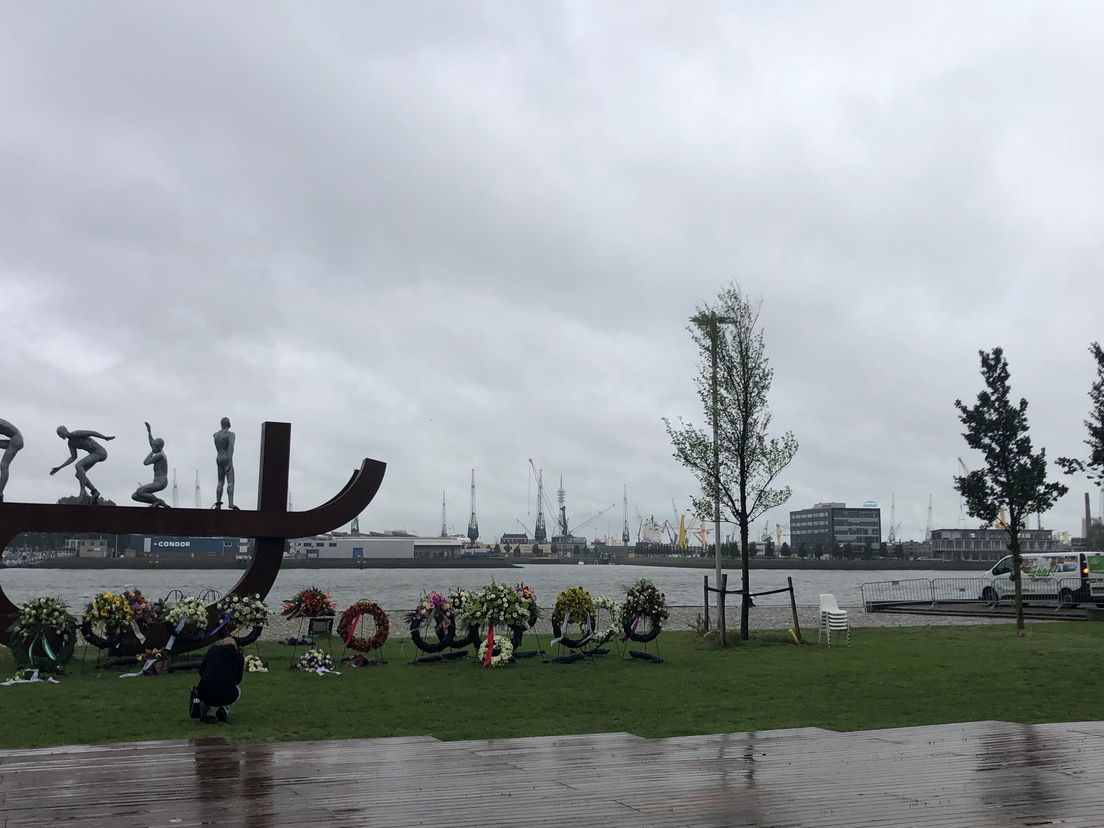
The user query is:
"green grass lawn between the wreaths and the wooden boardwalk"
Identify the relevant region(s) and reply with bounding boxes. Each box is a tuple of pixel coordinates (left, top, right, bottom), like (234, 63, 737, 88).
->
(0, 623, 1104, 747)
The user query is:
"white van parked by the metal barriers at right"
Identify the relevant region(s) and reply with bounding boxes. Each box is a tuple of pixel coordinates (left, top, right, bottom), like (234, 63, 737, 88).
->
(978, 552, 1104, 604)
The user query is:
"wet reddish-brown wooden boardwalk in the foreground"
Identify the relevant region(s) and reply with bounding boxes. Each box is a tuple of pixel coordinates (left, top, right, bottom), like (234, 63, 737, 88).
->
(0, 724, 1104, 828)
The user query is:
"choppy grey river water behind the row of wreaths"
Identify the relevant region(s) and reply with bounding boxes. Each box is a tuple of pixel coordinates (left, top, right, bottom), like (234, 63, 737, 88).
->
(2, 564, 974, 612)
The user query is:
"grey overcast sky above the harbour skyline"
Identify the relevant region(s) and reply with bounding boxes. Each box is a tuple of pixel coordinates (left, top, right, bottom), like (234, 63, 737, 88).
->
(0, 0, 1104, 540)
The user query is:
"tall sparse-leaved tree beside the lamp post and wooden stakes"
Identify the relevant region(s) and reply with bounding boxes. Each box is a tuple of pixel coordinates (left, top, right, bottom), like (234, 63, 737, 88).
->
(664, 285, 797, 640)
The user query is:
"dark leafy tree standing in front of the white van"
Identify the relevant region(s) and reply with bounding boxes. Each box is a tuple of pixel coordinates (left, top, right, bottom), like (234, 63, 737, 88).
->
(955, 348, 1068, 635)
